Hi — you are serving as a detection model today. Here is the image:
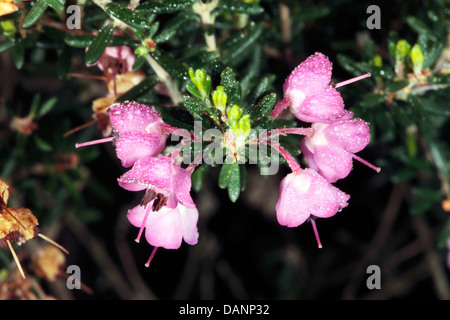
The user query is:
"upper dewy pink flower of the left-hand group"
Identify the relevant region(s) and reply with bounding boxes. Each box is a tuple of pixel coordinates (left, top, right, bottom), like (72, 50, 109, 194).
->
(108, 101, 166, 167)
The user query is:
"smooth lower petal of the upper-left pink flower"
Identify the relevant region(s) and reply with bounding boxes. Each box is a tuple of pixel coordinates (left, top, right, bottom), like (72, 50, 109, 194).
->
(116, 132, 166, 167)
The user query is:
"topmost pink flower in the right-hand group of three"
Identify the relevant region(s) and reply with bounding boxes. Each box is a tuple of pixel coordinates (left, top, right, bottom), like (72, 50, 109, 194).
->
(272, 52, 344, 122)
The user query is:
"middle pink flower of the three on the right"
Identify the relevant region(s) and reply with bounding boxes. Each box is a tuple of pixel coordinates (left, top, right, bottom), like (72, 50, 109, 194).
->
(300, 112, 370, 183)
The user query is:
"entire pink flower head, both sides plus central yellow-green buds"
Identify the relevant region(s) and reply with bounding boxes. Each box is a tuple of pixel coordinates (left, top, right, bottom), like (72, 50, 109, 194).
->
(77, 53, 379, 266)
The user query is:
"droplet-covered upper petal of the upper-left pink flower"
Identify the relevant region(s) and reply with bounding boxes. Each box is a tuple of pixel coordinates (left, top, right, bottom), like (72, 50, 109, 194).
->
(109, 101, 163, 134)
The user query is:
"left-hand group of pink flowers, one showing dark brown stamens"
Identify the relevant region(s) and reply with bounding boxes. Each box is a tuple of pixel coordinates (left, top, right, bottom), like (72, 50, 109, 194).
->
(77, 101, 198, 266)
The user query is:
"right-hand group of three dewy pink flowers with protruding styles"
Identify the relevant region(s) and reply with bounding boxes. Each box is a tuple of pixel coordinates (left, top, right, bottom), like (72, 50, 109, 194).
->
(272, 53, 379, 247)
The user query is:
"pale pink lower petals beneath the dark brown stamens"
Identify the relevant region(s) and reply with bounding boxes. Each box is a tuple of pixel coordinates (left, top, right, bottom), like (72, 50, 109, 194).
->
(127, 200, 198, 249)
